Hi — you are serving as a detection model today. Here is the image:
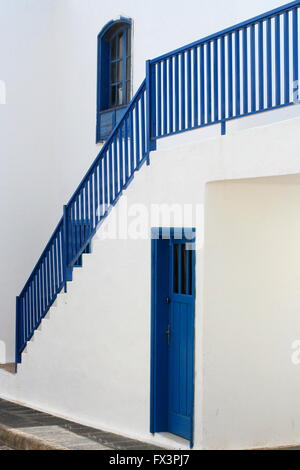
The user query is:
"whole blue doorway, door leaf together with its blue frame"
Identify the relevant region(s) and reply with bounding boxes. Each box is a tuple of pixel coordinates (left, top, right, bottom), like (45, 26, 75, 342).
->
(151, 229, 195, 447)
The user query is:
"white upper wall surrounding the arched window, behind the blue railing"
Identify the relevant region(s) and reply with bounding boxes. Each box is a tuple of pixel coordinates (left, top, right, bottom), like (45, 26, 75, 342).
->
(0, 0, 296, 361)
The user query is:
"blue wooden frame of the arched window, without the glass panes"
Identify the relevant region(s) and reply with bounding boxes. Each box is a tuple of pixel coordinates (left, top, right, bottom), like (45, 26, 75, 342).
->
(96, 17, 132, 143)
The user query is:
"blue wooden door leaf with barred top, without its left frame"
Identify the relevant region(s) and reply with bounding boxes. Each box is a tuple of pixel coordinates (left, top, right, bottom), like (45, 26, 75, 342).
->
(166, 240, 195, 440)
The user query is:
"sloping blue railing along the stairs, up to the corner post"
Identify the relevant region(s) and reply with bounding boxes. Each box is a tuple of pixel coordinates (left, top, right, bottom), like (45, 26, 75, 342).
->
(16, 82, 149, 363)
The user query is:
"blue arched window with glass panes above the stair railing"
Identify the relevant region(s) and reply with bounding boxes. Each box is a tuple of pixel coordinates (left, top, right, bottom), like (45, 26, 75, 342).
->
(96, 18, 131, 143)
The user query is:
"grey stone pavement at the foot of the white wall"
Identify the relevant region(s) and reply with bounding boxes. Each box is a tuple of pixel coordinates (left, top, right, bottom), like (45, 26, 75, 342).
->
(0, 399, 161, 450)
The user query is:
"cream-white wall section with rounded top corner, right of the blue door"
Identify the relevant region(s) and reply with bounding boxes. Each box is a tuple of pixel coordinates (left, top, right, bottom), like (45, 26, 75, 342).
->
(202, 175, 300, 449)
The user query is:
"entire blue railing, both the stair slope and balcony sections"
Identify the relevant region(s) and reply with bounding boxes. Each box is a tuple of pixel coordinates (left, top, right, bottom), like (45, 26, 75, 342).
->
(16, 1, 300, 363)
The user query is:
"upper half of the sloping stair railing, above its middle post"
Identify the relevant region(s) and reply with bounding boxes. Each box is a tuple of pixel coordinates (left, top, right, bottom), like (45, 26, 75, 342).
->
(65, 81, 149, 269)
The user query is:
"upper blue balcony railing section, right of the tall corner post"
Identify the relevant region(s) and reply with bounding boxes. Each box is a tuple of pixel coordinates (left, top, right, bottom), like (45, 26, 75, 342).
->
(148, 1, 300, 140)
